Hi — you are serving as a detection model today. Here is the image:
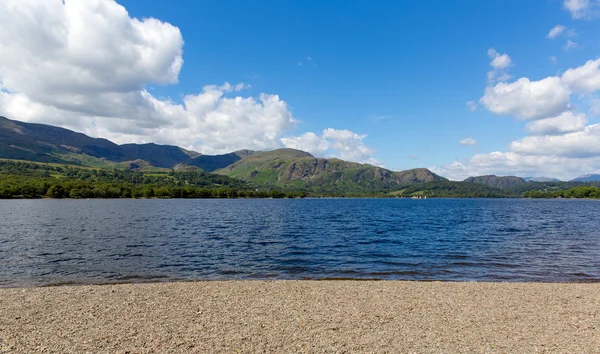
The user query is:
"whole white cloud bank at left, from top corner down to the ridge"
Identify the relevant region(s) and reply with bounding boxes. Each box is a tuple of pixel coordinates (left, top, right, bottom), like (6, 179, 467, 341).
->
(0, 0, 296, 153)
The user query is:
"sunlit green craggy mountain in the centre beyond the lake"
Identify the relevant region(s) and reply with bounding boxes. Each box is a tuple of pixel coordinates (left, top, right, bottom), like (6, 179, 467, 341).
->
(215, 149, 446, 192)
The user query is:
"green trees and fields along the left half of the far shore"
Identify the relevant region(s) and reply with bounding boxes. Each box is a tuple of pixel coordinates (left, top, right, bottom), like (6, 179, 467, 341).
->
(0, 160, 306, 199)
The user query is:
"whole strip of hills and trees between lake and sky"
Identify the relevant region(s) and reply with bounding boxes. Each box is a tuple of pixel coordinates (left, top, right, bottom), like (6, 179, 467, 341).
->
(0, 117, 600, 198)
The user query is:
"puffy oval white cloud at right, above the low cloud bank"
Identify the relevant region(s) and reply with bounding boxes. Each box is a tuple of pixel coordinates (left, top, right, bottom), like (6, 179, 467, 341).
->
(479, 77, 571, 119)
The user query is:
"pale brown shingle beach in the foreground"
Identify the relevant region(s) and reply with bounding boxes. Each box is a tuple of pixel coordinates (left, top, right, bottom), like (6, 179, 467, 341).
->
(0, 281, 600, 353)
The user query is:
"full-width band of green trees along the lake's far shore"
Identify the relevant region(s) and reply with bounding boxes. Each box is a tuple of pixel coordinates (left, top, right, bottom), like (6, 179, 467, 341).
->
(0, 160, 600, 199)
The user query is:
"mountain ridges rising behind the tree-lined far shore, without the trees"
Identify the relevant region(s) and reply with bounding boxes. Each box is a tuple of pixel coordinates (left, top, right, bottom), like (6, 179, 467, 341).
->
(0, 117, 600, 192)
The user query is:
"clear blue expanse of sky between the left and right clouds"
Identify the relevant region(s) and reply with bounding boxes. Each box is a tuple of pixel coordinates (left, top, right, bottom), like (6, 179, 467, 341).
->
(121, 0, 600, 174)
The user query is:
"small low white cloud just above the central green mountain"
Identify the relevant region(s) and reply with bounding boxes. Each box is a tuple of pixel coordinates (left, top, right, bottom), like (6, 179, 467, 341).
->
(281, 128, 382, 166)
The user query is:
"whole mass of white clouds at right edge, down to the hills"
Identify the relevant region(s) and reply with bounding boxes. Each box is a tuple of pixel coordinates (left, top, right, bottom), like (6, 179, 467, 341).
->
(432, 51, 600, 180)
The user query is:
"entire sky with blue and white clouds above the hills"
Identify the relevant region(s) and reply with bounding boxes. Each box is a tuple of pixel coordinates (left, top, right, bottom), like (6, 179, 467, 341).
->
(0, 0, 600, 180)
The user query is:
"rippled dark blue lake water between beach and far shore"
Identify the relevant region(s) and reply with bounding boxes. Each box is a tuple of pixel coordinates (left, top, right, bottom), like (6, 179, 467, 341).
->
(0, 199, 600, 287)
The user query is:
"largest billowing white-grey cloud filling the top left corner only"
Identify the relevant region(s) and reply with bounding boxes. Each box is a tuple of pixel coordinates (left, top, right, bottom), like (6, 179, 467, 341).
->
(0, 0, 183, 119)
